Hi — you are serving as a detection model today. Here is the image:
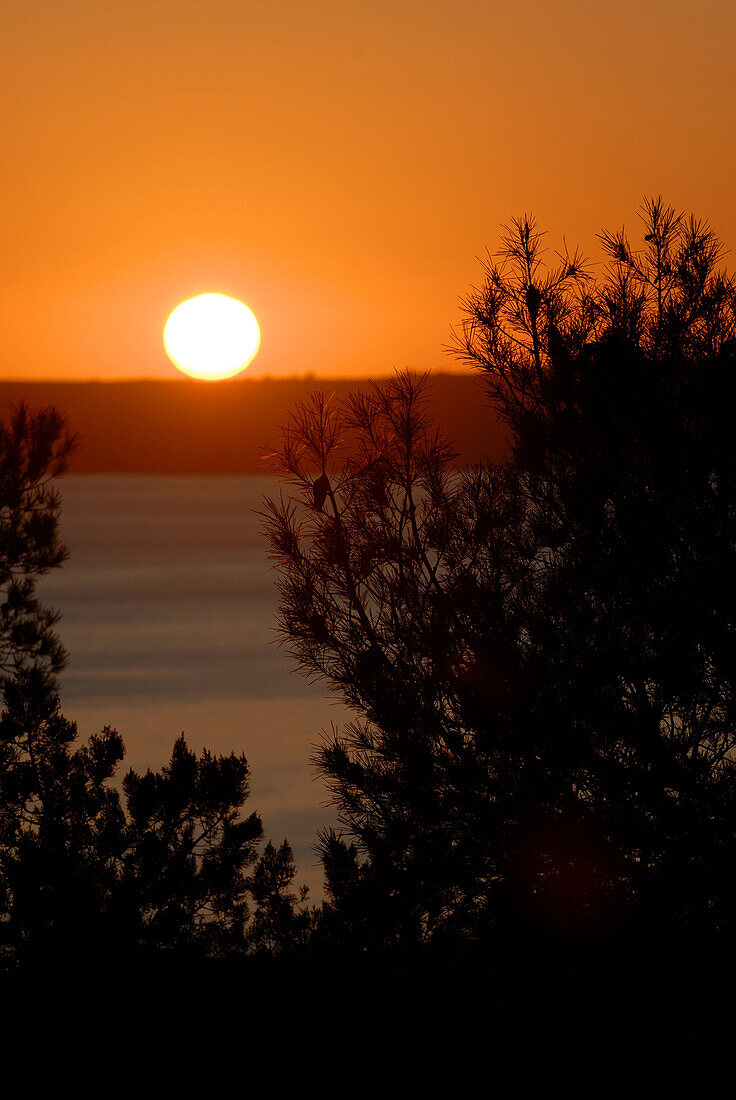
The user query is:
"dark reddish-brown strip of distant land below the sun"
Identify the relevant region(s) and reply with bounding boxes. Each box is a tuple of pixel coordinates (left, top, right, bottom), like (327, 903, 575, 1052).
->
(0, 374, 504, 474)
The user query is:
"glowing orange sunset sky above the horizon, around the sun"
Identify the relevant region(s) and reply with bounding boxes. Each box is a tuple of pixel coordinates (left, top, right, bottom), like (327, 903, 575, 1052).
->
(0, 0, 736, 378)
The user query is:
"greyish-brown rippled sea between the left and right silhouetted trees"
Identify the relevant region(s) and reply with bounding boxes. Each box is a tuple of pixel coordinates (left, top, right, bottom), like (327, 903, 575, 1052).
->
(39, 474, 349, 901)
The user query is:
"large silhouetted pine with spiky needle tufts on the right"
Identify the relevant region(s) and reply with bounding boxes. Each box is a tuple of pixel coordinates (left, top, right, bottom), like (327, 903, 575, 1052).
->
(268, 200, 736, 944)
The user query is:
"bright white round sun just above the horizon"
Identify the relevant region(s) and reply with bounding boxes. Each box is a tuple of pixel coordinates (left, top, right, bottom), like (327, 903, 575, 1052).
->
(164, 294, 261, 382)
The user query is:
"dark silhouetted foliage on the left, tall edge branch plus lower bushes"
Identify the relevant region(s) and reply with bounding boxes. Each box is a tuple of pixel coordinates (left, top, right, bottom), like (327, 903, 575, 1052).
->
(0, 406, 304, 968)
